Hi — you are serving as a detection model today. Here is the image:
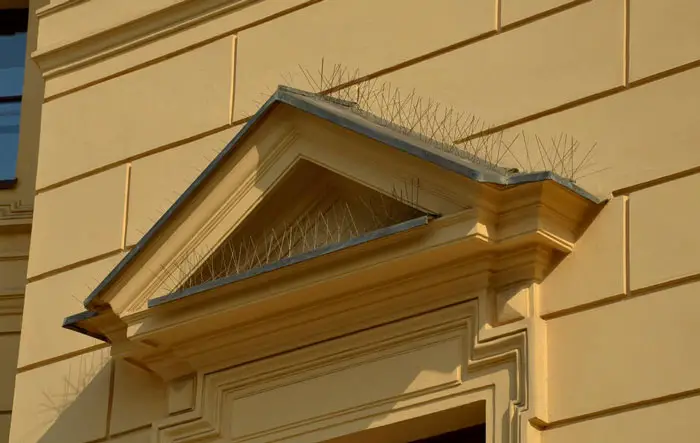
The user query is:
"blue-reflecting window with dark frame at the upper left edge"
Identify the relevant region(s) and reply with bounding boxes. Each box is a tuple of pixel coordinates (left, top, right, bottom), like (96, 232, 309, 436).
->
(0, 9, 29, 188)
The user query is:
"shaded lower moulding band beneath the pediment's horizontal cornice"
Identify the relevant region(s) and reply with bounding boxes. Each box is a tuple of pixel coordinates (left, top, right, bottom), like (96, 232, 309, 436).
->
(134, 246, 488, 374)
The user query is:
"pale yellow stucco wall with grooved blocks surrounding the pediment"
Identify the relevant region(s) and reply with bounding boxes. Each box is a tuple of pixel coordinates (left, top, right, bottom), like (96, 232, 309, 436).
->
(5, 0, 700, 443)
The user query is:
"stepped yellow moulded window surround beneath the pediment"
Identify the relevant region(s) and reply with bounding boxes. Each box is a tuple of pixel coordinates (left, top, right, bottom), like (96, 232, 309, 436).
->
(154, 300, 528, 443)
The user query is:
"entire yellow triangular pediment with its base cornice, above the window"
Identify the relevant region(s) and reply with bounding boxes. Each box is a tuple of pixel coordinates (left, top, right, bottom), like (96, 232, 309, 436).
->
(66, 89, 600, 380)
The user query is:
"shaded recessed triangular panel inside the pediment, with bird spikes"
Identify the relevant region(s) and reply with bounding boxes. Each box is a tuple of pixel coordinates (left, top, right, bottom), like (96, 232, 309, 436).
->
(168, 160, 426, 298)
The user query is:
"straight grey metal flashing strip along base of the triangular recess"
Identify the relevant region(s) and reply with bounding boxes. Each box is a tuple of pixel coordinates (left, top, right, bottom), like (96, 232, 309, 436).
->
(148, 215, 432, 308)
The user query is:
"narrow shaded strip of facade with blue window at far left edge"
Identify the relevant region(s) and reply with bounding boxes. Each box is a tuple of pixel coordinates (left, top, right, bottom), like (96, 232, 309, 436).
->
(0, 2, 36, 441)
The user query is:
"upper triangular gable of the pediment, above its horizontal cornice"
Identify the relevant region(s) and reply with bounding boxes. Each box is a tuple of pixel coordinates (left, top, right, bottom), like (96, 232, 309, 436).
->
(75, 87, 496, 315)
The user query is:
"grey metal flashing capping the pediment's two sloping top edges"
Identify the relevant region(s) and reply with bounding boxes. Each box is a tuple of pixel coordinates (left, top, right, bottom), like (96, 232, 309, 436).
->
(79, 86, 600, 308)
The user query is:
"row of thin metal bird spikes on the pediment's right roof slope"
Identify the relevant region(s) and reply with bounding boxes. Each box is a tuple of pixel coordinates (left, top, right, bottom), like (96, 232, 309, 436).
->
(282, 58, 598, 181)
